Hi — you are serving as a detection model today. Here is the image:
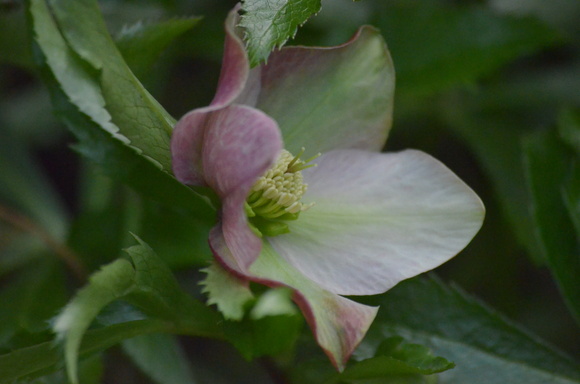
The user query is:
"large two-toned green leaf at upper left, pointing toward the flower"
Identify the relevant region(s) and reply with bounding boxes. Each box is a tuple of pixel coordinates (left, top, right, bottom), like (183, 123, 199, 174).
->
(29, 0, 212, 219)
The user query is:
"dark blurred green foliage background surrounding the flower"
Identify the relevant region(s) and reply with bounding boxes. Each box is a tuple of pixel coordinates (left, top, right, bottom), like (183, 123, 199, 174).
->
(0, 0, 580, 383)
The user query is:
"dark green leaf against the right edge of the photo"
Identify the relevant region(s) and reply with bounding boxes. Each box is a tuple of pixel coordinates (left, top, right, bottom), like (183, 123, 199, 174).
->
(523, 132, 580, 322)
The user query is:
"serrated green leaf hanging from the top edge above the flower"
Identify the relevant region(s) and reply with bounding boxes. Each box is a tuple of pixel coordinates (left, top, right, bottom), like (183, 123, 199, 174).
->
(240, 0, 321, 67)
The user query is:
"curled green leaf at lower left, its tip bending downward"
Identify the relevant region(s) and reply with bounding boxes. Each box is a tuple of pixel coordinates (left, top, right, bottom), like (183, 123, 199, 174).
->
(53, 238, 220, 383)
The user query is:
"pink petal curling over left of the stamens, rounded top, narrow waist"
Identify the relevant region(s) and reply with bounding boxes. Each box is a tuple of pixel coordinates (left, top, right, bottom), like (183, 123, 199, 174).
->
(202, 104, 282, 273)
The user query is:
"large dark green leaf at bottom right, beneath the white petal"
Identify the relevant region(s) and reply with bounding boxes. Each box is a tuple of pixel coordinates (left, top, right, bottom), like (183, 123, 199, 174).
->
(362, 278, 580, 384)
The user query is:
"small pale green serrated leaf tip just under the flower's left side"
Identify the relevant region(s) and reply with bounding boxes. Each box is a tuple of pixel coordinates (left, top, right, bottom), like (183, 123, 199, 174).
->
(201, 261, 254, 320)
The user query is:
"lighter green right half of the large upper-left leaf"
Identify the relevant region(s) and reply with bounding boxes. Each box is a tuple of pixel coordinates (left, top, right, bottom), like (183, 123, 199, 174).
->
(46, 0, 175, 170)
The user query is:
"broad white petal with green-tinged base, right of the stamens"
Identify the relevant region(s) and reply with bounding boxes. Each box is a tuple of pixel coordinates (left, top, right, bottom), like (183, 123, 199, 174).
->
(268, 150, 485, 295)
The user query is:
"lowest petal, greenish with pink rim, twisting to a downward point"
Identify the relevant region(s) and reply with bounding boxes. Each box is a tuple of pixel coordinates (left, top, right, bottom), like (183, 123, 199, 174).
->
(210, 235, 378, 371)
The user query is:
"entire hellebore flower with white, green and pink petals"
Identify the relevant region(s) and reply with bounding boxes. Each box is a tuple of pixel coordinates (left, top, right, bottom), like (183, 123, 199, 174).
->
(171, 9, 484, 370)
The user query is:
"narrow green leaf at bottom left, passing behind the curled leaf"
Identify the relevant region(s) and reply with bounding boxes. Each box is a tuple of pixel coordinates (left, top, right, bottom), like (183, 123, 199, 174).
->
(0, 319, 177, 384)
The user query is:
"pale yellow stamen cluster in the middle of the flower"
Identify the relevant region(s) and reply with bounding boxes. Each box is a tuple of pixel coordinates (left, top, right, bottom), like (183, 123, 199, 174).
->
(246, 149, 318, 219)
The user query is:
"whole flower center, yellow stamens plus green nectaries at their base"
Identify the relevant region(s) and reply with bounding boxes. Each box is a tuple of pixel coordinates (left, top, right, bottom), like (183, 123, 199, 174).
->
(245, 148, 320, 236)
